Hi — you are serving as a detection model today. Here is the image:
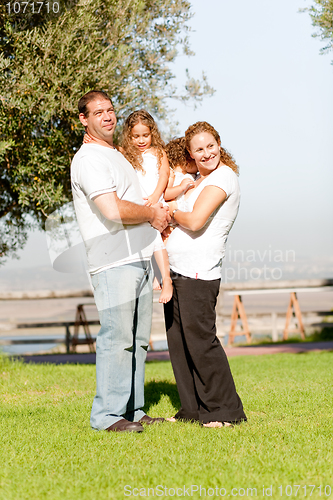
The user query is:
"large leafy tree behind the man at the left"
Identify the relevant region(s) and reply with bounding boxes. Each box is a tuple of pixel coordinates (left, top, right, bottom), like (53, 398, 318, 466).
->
(0, 0, 213, 257)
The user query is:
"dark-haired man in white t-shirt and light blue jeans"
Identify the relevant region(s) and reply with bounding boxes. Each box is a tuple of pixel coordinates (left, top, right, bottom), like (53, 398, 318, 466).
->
(71, 91, 170, 432)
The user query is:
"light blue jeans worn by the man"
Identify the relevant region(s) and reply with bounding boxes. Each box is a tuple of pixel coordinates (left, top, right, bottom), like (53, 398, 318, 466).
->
(90, 261, 153, 430)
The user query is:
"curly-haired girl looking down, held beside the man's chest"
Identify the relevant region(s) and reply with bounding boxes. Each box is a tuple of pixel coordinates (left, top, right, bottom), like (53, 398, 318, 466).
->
(119, 109, 173, 304)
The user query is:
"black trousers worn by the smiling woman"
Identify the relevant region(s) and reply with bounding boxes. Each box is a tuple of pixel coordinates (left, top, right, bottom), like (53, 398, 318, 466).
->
(164, 273, 246, 423)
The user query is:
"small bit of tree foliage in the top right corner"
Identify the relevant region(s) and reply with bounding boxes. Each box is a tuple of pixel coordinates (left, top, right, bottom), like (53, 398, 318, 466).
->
(303, 0, 333, 58)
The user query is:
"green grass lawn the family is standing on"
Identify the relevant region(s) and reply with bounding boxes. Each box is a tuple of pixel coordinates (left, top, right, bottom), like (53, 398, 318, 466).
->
(0, 352, 333, 500)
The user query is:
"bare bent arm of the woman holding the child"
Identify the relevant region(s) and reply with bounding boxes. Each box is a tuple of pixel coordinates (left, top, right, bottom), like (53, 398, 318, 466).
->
(169, 186, 227, 231)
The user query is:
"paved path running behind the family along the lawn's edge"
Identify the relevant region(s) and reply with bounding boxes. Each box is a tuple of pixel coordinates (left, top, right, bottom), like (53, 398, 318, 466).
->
(16, 341, 333, 365)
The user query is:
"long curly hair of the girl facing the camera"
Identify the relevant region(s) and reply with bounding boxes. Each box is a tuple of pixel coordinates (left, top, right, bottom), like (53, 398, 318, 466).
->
(121, 109, 165, 173)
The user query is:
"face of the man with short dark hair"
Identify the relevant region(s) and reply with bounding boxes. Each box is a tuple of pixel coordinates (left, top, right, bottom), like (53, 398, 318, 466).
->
(79, 98, 117, 144)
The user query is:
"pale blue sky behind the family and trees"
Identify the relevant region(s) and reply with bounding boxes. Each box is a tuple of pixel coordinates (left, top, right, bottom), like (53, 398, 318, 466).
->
(6, 0, 333, 277)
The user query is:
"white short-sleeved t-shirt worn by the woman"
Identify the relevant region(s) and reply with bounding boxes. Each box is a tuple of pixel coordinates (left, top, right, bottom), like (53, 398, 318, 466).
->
(166, 165, 240, 280)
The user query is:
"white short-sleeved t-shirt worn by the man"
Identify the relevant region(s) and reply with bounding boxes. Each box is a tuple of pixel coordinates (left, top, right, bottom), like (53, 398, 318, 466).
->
(71, 144, 163, 274)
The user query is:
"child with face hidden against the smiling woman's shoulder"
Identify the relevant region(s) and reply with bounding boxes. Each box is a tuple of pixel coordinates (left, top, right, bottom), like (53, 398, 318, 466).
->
(164, 137, 198, 201)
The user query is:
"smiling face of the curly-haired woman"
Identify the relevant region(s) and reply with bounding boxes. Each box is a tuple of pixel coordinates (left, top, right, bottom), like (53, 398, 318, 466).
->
(190, 132, 220, 170)
